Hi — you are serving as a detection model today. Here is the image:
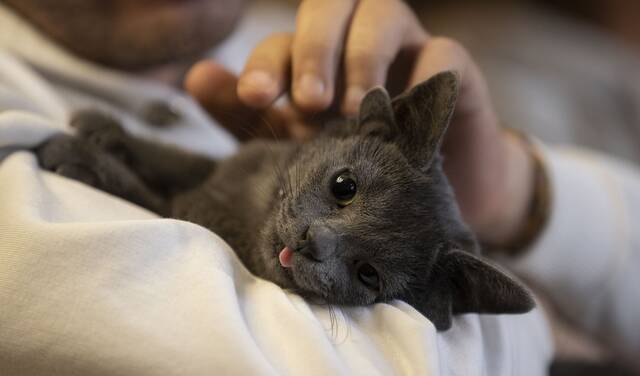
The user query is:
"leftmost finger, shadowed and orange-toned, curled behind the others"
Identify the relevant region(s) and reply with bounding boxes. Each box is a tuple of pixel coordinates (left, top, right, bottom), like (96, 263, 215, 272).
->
(185, 61, 289, 140)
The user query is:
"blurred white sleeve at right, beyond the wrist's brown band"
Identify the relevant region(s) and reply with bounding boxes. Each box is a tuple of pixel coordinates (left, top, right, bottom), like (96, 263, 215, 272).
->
(514, 148, 640, 353)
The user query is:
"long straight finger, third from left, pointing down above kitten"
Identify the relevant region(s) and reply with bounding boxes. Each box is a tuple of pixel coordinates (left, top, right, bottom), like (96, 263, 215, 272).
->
(292, 0, 356, 111)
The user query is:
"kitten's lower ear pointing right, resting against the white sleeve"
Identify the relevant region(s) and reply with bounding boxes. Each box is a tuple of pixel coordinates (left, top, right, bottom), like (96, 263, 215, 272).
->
(407, 250, 535, 330)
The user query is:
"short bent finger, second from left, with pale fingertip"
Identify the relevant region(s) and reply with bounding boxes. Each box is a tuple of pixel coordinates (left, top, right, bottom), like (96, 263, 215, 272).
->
(238, 33, 293, 108)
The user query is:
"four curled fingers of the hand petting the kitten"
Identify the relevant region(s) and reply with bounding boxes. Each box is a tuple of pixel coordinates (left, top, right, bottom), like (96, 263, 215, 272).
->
(185, 0, 427, 139)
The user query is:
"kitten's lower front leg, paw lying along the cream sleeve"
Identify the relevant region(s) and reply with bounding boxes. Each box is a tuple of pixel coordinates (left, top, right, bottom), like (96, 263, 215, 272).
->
(34, 135, 168, 215)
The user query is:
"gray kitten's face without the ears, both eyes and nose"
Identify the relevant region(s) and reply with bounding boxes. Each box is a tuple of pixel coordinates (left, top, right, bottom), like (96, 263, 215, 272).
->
(265, 136, 462, 305)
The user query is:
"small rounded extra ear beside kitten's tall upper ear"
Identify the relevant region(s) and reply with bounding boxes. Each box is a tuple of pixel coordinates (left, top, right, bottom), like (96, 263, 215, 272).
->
(358, 86, 395, 138)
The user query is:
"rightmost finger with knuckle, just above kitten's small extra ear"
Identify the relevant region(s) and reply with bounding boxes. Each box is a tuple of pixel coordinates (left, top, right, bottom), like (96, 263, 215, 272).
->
(342, 0, 427, 114)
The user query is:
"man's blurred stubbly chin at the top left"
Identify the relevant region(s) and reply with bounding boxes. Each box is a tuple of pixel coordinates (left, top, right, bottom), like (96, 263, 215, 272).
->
(5, 0, 244, 70)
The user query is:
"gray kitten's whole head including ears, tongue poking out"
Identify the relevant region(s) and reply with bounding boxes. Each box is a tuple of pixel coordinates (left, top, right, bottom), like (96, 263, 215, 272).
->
(263, 72, 533, 330)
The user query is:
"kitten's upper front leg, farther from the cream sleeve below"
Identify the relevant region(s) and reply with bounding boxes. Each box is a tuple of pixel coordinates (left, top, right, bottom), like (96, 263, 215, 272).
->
(71, 111, 215, 197)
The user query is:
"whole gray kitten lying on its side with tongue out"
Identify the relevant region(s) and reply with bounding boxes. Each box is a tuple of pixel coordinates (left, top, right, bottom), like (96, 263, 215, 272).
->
(36, 72, 534, 330)
